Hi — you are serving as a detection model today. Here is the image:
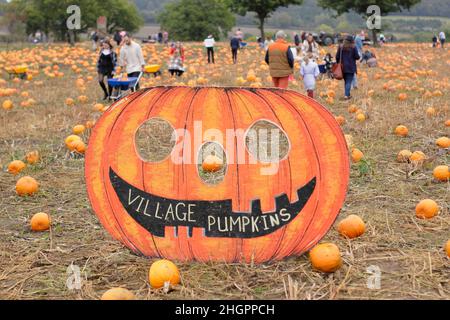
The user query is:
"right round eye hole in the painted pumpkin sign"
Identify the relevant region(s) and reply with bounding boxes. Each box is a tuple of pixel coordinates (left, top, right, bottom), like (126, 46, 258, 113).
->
(245, 120, 291, 163)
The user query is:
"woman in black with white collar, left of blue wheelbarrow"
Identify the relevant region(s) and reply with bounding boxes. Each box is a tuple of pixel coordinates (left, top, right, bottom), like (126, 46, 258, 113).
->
(97, 38, 117, 100)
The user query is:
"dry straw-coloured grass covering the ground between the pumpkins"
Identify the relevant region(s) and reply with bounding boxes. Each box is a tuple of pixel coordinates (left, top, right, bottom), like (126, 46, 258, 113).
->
(0, 44, 450, 299)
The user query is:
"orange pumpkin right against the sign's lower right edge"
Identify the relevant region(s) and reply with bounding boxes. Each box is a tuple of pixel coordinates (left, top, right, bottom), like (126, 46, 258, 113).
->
(309, 243, 342, 273)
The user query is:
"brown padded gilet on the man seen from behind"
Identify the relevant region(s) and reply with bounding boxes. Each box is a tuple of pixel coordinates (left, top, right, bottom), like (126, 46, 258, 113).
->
(266, 40, 294, 78)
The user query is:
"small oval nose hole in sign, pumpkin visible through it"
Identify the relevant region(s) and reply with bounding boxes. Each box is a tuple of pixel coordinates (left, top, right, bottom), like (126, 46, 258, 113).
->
(197, 142, 227, 186)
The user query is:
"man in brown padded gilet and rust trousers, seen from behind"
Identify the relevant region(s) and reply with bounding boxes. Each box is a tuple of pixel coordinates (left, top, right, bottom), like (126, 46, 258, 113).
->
(265, 30, 294, 89)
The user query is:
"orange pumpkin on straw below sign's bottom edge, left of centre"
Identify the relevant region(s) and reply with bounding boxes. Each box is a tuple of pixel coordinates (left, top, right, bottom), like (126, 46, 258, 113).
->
(148, 260, 180, 289)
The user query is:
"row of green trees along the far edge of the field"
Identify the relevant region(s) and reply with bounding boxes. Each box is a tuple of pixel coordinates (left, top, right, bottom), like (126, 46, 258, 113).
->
(0, 0, 420, 41)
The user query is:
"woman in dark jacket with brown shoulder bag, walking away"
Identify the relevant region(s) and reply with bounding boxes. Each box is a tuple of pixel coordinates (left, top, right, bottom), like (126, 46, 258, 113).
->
(336, 35, 361, 100)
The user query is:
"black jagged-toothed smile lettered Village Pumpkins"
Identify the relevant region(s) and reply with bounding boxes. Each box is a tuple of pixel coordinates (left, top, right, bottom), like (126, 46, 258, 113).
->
(109, 168, 316, 238)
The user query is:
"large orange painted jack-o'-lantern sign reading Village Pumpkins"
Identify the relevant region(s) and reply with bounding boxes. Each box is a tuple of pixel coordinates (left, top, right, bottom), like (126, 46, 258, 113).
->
(86, 87, 349, 263)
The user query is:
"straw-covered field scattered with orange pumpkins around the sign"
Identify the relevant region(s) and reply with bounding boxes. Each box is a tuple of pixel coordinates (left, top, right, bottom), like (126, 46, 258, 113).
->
(0, 42, 450, 300)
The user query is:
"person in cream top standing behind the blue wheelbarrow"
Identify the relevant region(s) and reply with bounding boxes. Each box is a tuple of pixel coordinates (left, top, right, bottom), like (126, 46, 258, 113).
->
(119, 34, 145, 90)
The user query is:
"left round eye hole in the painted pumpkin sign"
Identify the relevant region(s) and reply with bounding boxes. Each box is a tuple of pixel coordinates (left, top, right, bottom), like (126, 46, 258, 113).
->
(135, 118, 176, 162)
